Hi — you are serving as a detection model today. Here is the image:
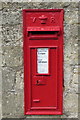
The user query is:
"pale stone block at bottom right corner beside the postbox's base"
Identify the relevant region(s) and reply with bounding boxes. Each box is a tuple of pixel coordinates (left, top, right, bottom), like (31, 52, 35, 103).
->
(64, 93, 78, 118)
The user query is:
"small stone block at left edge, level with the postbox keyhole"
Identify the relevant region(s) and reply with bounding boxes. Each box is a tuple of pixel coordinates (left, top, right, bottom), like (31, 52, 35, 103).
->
(2, 67, 16, 92)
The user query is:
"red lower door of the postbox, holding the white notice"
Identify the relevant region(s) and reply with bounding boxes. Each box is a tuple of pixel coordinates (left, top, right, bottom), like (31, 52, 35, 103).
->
(30, 47, 58, 110)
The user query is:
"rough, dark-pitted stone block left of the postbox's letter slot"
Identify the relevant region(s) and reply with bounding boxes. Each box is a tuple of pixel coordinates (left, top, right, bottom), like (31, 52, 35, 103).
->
(2, 25, 23, 46)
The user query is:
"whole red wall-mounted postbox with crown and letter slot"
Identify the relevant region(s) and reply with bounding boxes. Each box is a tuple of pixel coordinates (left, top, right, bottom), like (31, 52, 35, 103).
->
(23, 9, 63, 115)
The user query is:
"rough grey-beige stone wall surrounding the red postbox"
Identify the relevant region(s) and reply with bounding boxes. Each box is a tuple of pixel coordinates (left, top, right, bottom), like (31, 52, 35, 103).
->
(0, 2, 80, 118)
